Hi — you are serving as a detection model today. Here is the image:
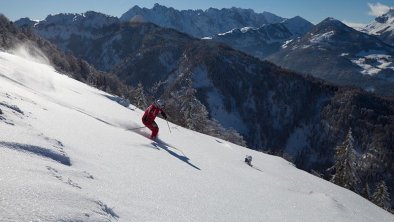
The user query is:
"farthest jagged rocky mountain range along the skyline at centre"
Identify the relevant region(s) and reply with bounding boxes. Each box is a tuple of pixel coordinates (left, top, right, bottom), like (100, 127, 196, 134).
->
(120, 4, 285, 38)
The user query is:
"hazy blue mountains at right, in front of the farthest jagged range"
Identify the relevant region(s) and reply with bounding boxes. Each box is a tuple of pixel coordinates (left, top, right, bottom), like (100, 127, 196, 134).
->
(202, 15, 394, 96)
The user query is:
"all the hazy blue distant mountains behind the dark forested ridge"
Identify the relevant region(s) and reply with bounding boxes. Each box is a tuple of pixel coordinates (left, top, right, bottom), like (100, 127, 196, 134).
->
(120, 4, 394, 96)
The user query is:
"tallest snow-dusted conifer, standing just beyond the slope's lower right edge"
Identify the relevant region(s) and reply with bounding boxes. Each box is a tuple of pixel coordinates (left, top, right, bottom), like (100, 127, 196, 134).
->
(331, 129, 359, 191)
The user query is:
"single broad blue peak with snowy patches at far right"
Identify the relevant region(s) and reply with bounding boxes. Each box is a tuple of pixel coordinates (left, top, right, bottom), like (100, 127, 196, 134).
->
(267, 18, 394, 96)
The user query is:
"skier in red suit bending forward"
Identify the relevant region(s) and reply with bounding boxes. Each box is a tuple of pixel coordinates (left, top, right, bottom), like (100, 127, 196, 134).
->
(142, 99, 167, 139)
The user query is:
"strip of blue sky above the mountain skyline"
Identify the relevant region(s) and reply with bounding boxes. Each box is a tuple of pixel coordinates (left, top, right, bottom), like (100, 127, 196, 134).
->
(0, 0, 394, 24)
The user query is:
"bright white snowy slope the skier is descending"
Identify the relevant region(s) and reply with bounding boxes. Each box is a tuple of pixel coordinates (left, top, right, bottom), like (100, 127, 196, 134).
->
(0, 49, 394, 221)
